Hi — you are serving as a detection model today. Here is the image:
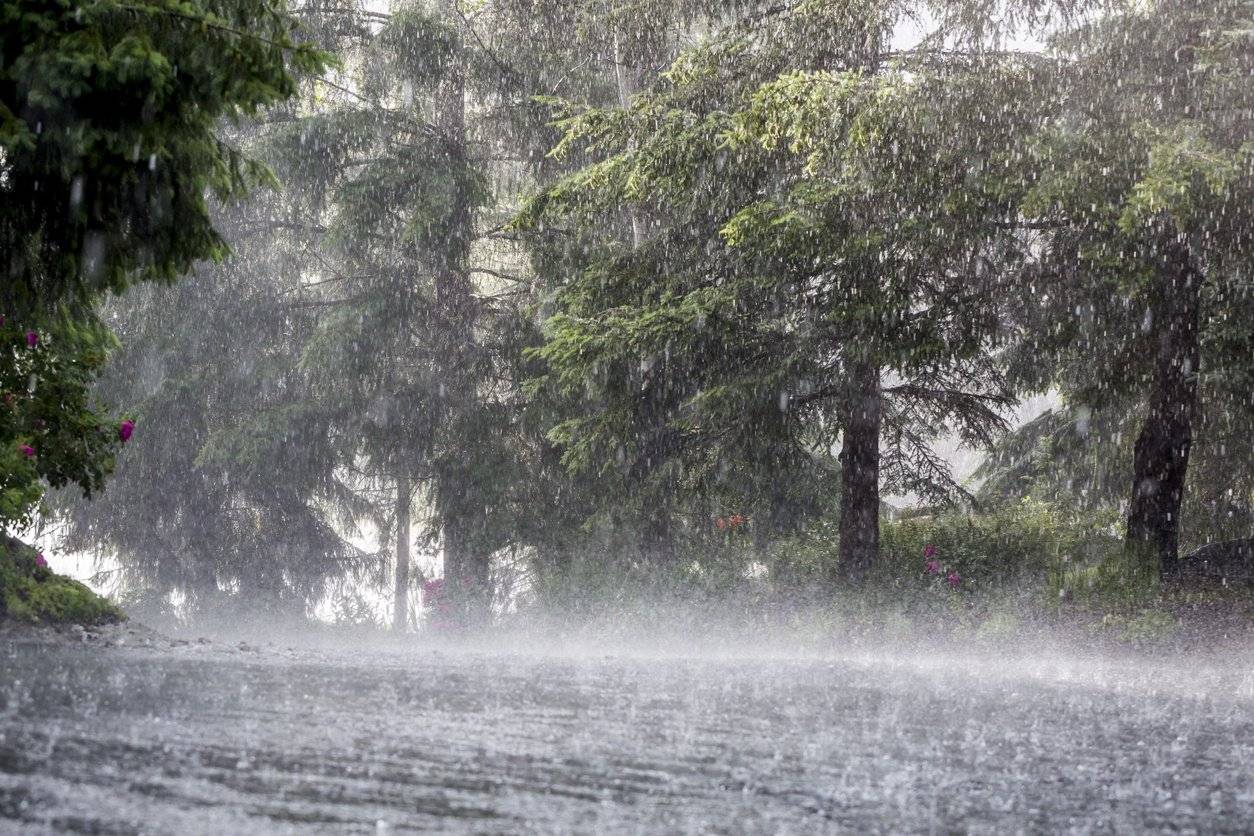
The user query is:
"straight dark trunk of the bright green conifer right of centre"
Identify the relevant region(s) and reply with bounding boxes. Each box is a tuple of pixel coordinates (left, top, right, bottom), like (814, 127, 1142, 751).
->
(838, 361, 883, 587)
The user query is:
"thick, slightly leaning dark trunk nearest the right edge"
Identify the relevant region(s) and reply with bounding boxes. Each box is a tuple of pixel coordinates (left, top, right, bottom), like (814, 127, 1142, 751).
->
(1125, 243, 1201, 577)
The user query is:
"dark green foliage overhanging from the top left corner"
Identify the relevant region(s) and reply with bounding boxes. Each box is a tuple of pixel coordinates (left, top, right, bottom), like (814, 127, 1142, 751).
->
(0, 0, 326, 317)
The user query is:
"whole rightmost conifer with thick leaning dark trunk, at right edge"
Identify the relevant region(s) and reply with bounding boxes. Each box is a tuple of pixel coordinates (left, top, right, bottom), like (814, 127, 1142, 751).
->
(1007, 0, 1254, 578)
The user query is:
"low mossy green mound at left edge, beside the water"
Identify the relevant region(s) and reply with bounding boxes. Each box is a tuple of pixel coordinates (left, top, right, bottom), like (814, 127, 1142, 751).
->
(0, 536, 125, 625)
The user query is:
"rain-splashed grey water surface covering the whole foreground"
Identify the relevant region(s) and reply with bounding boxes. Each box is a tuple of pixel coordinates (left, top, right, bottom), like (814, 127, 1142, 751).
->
(0, 640, 1254, 833)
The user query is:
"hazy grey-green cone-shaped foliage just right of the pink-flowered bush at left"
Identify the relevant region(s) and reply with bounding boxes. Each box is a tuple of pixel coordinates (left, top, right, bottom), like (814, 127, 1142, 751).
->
(53, 269, 380, 615)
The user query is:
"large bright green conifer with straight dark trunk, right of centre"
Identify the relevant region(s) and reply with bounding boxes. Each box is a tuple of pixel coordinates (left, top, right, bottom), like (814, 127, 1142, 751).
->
(520, 4, 1047, 583)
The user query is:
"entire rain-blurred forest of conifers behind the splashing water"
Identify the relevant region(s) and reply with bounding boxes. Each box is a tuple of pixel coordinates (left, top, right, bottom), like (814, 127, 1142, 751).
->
(0, 0, 1254, 629)
